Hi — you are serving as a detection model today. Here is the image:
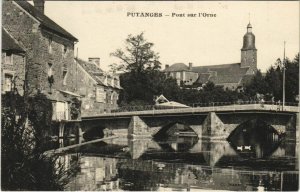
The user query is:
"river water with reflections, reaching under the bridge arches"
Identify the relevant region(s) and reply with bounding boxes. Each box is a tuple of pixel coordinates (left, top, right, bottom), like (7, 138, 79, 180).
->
(55, 121, 299, 191)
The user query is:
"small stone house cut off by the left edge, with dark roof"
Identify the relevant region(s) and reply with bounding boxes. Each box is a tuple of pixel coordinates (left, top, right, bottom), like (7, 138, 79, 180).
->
(1, 28, 25, 95)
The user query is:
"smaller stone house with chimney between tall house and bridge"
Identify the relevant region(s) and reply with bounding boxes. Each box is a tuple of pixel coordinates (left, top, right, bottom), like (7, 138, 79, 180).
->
(75, 58, 122, 116)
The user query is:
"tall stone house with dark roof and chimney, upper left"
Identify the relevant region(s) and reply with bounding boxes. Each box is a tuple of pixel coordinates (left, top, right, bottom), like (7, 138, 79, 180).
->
(2, 0, 78, 121)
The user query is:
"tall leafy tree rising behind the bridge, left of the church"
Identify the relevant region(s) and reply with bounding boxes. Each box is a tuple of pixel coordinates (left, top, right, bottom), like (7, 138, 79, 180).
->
(111, 33, 179, 105)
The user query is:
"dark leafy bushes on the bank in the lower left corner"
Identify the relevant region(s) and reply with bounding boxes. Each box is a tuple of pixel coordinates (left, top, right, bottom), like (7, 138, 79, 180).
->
(1, 73, 78, 191)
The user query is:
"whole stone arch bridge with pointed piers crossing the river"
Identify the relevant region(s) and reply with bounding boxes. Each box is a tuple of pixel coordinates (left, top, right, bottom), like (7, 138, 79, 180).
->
(79, 104, 299, 141)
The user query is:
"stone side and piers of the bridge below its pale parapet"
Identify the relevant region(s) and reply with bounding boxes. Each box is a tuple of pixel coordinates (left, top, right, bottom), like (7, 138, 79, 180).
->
(83, 111, 296, 139)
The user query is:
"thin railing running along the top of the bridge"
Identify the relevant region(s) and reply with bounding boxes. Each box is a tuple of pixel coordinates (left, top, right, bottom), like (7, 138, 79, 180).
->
(111, 101, 299, 113)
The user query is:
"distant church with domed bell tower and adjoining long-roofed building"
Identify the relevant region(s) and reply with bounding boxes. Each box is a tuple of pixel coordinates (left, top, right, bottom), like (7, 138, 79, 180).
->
(164, 23, 257, 90)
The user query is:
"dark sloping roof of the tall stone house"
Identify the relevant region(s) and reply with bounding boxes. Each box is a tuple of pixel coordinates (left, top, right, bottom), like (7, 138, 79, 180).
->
(15, 0, 78, 41)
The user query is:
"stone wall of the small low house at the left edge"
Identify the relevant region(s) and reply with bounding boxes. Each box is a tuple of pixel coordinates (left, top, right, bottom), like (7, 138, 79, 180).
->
(1, 52, 25, 95)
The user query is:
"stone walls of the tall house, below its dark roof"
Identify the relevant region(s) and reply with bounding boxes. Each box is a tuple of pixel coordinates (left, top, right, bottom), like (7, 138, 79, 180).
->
(2, 1, 75, 94)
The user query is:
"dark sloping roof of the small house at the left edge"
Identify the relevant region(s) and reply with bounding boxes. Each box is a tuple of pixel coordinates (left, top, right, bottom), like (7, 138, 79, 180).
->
(1, 27, 25, 53)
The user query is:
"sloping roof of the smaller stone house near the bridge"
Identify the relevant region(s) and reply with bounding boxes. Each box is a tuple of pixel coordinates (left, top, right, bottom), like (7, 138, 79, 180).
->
(75, 59, 105, 85)
